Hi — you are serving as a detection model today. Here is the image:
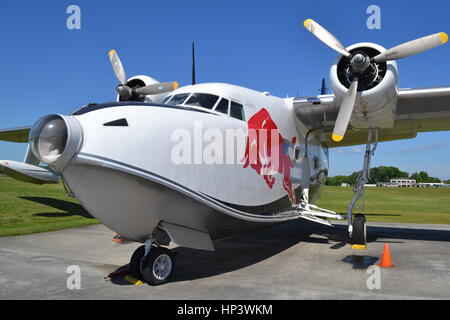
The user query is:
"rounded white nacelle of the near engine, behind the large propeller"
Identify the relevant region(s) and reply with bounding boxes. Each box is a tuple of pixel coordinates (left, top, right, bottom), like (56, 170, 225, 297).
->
(330, 43, 398, 128)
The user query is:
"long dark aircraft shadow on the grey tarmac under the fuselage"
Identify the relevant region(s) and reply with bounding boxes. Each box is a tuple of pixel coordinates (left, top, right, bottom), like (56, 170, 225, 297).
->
(112, 220, 450, 285)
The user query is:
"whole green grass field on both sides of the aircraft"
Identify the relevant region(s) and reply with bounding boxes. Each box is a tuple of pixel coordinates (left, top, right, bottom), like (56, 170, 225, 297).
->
(0, 176, 450, 237)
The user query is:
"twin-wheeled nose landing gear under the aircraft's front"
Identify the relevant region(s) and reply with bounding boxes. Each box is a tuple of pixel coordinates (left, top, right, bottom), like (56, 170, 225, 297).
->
(130, 239, 175, 286)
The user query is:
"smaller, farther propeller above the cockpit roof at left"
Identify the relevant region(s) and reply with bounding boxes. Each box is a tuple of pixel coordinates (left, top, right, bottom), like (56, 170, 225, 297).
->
(109, 50, 178, 101)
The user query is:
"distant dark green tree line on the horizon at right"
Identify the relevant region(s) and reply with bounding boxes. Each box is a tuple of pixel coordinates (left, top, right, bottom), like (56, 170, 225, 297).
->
(325, 166, 450, 186)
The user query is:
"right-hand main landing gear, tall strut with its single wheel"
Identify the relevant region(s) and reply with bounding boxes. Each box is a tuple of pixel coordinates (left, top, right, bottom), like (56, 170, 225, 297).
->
(347, 128, 379, 249)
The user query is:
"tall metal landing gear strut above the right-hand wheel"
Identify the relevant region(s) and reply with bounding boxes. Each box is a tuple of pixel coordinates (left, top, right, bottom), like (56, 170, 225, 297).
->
(347, 128, 379, 236)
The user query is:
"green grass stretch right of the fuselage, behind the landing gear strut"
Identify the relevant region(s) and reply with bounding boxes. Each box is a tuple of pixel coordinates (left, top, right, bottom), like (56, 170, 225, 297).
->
(317, 186, 450, 224)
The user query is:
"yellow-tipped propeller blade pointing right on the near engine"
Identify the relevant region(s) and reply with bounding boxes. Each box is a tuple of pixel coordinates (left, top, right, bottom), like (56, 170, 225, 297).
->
(373, 32, 448, 62)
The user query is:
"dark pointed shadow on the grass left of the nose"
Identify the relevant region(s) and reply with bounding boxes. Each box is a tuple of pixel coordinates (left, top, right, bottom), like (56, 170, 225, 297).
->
(19, 197, 94, 219)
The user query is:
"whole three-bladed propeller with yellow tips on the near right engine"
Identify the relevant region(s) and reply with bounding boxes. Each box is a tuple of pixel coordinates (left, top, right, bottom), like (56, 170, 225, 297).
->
(303, 19, 448, 142)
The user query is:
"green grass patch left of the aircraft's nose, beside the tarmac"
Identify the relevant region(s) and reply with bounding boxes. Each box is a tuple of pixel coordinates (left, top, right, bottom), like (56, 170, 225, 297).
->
(0, 177, 98, 237)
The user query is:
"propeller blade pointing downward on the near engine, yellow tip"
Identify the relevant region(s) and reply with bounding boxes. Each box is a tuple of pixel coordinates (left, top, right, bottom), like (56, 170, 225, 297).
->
(331, 77, 358, 142)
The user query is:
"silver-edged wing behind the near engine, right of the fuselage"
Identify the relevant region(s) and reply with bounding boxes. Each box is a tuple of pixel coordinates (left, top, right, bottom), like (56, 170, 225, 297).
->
(294, 86, 450, 148)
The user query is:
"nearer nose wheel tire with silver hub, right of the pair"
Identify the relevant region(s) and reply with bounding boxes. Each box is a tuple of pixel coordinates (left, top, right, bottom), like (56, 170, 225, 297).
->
(141, 247, 175, 286)
